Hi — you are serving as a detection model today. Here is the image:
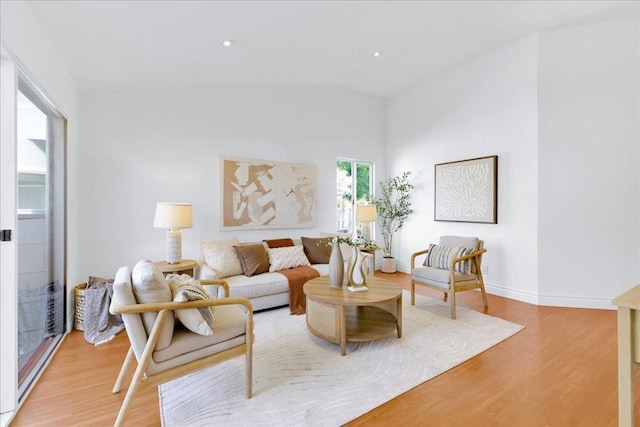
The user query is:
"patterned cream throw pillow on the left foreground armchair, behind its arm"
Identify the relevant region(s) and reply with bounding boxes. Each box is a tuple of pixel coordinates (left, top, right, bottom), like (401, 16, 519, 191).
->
(167, 274, 216, 335)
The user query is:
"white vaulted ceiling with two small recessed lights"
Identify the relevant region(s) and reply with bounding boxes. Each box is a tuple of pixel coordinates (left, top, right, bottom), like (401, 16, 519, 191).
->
(28, 0, 639, 97)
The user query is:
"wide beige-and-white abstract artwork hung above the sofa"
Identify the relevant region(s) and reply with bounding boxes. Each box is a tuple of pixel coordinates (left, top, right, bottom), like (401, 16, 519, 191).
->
(220, 158, 317, 230)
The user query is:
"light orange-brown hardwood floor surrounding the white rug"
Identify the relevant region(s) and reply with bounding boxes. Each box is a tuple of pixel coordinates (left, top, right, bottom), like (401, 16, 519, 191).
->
(12, 272, 640, 426)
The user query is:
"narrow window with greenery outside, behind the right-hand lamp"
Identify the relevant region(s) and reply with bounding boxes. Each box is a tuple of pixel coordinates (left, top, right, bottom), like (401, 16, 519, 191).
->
(336, 159, 374, 236)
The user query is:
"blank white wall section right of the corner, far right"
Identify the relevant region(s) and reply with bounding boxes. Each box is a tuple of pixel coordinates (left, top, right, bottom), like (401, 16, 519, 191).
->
(538, 20, 640, 307)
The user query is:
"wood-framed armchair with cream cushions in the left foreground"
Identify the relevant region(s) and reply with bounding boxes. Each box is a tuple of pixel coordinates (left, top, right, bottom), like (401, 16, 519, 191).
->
(109, 267, 254, 426)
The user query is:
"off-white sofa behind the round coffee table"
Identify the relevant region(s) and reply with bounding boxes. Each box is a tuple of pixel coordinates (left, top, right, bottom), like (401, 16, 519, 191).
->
(195, 239, 373, 311)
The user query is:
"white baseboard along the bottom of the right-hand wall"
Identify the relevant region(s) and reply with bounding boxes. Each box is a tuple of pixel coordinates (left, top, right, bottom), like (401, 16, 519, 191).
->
(397, 263, 617, 310)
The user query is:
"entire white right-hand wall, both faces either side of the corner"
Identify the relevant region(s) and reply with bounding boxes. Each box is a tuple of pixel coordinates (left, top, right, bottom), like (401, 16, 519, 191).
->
(387, 20, 640, 308)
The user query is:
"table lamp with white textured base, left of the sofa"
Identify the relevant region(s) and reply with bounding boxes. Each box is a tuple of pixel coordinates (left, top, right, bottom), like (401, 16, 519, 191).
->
(153, 202, 193, 264)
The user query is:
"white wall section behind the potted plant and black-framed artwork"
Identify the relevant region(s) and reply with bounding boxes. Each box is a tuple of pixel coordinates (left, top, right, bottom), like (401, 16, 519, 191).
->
(387, 36, 538, 302)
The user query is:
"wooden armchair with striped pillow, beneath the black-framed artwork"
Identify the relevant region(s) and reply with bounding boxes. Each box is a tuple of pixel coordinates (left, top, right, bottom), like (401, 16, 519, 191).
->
(411, 236, 489, 319)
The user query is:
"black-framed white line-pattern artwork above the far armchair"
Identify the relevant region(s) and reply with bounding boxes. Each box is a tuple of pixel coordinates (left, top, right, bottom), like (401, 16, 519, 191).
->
(434, 156, 498, 224)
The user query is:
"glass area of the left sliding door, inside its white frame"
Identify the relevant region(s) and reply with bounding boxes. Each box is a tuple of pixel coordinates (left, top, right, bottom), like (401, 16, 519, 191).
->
(16, 88, 64, 398)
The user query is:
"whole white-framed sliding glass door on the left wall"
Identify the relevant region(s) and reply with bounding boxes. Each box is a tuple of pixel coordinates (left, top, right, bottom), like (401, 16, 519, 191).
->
(0, 46, 66, 419)
